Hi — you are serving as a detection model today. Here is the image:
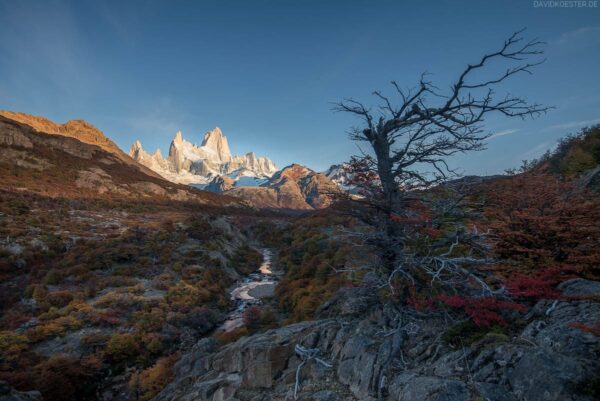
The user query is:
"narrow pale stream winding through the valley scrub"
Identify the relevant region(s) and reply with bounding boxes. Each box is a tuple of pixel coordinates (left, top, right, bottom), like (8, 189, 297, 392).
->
(217, 249, 277, 332)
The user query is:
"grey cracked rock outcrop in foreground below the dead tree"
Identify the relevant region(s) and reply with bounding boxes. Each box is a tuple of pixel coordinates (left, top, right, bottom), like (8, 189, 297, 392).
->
(155, 280, 600, 401)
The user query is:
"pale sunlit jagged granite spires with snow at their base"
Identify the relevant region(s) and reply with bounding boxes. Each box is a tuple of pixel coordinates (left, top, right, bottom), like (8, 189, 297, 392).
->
(129, 127, 277, 185)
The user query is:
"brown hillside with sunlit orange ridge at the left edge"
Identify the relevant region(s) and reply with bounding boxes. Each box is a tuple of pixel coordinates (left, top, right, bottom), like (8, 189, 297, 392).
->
(0, 112, 237, 205)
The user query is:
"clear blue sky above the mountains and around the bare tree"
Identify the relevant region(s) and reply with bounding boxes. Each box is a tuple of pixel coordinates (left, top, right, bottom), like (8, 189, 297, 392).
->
(0, 0, 600, 174)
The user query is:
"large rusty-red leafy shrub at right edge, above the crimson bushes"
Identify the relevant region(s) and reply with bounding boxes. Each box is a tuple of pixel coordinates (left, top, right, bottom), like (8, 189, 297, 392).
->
(484, 172, 600, 282)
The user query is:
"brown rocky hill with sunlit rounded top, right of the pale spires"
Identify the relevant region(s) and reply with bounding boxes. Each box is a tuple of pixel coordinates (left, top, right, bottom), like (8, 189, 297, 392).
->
(206, 164, 339, 210)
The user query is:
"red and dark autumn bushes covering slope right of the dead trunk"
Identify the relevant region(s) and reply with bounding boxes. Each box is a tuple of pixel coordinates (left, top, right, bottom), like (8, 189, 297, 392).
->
(338, 126, 600, 334)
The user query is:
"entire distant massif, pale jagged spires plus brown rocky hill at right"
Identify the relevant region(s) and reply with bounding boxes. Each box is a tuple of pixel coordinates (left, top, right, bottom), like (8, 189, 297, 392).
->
(129, 127, 338, 210)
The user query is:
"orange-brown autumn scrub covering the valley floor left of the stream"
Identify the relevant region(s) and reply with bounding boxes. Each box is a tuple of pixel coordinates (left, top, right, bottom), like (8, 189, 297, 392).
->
(0, 191, 257, 401)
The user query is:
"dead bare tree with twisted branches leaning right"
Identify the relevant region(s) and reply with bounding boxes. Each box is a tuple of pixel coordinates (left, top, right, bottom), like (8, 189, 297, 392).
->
(334, 30, 549, 279)
